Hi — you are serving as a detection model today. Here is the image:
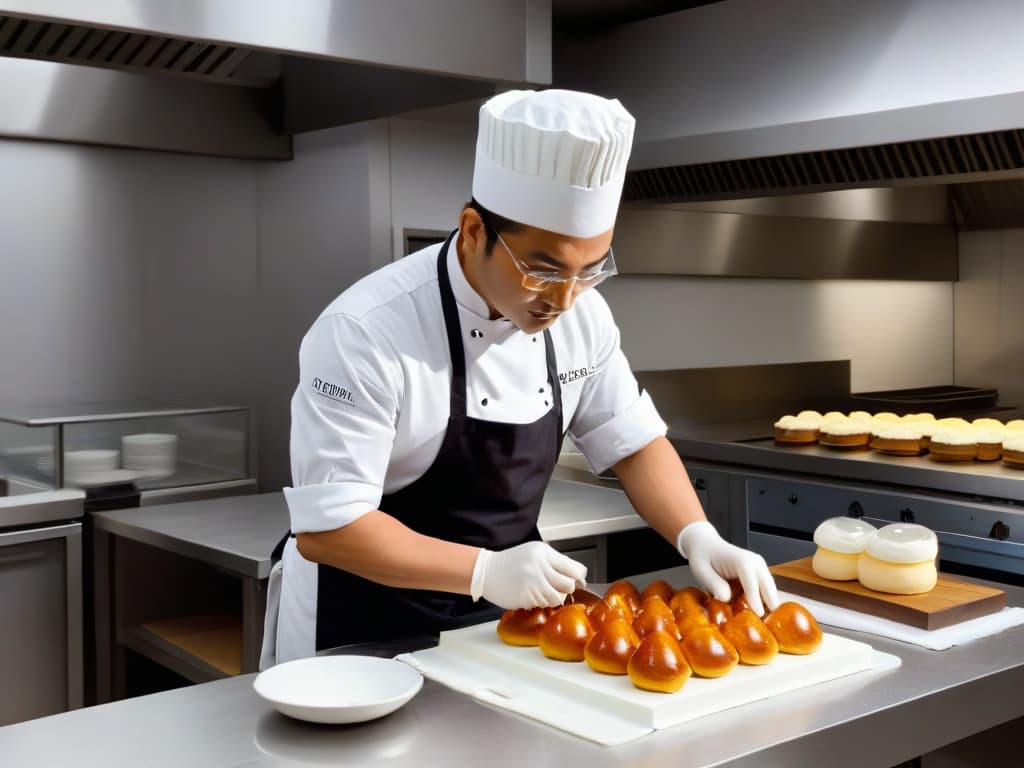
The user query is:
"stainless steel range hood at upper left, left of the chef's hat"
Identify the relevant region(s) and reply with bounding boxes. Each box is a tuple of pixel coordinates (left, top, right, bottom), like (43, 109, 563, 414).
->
(0, 0, 551, 159)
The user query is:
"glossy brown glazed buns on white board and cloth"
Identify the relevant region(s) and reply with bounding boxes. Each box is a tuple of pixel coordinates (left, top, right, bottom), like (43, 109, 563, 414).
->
(399, 580, 898, 743)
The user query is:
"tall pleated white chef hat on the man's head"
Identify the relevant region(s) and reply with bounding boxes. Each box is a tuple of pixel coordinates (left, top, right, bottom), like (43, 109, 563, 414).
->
(473, 89, 636, 238)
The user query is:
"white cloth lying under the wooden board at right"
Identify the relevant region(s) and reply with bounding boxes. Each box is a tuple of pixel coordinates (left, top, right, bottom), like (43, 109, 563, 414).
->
(779, 592, 1024, 650)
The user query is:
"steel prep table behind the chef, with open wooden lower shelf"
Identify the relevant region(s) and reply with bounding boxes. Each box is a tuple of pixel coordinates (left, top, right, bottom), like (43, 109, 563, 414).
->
(92, 480, 646, 702)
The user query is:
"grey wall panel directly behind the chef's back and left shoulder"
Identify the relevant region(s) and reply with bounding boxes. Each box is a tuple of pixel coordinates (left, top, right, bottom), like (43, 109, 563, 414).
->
(250, 122, 390, 489)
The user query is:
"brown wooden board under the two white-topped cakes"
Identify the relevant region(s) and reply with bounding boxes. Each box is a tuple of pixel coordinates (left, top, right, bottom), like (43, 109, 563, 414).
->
(771, 557, 1007, 630)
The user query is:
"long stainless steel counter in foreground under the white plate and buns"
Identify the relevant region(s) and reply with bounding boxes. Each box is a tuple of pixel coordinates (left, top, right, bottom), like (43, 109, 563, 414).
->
(0, 567, 1024, 768)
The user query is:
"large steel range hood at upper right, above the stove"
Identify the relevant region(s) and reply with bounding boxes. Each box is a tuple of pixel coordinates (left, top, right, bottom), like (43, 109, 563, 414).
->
(556, 0, 1024, 228)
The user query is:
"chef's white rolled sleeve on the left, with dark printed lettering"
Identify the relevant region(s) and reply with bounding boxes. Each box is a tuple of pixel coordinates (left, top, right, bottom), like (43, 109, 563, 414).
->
(285, 315, 401, 534)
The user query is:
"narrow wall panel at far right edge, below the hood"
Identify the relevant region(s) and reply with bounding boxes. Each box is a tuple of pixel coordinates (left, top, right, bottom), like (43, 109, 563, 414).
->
(953, 229, 1024, 407)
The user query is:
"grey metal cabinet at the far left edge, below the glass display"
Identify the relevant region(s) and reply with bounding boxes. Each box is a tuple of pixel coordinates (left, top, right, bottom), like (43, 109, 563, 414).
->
(0, 522, 82, 725)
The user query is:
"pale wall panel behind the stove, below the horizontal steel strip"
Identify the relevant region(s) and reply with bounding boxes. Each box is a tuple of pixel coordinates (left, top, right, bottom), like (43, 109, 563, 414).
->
(599, 276, 952, 391)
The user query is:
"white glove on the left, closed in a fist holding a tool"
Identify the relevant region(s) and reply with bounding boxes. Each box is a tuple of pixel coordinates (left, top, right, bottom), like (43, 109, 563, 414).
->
(470, 542, 587, 609)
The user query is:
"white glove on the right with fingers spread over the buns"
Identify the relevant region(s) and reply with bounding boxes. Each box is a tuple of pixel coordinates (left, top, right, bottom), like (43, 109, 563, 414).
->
(676, 520, 778, 616)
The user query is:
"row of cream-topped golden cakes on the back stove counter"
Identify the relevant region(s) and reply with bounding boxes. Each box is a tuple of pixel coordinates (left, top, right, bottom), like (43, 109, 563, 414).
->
(774, 411, 1024, 469)
